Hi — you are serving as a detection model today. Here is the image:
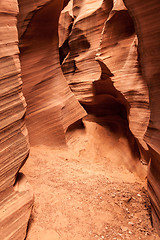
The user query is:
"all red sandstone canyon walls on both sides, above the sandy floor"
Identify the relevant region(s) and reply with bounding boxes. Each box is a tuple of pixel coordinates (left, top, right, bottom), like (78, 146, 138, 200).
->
(0, 0, 160, 240)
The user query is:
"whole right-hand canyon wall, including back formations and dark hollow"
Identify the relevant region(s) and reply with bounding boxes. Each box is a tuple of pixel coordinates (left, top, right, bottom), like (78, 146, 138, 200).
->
(59, 0, 160, 234)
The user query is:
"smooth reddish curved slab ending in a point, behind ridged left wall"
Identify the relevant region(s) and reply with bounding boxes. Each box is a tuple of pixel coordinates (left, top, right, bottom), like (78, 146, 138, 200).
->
(18, 0, 85, 146)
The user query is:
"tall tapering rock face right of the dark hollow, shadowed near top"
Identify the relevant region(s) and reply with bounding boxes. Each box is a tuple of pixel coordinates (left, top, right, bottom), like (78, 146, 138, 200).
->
(98, 1, 149, 149)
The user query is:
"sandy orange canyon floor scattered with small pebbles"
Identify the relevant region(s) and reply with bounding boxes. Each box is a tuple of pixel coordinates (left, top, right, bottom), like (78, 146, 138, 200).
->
(21, 120, 159, 240)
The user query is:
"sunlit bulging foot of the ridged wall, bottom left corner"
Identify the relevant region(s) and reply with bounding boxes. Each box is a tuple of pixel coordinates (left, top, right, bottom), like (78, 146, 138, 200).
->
(0, 174, 33, 240)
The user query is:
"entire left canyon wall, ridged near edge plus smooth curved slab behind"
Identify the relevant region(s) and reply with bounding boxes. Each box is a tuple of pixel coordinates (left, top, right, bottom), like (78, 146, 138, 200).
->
(0, 0, 86, 237)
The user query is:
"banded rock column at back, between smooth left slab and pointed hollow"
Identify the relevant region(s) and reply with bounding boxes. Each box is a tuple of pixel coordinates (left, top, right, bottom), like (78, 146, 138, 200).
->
(62, 0, 112, 100)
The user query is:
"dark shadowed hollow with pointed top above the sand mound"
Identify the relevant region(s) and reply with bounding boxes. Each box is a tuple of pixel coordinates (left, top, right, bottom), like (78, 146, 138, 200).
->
(80, 60, 141, 159)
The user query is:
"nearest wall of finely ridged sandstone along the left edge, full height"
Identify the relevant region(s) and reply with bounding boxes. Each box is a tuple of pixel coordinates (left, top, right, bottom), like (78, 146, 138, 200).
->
(0, 0, 33, 240)
